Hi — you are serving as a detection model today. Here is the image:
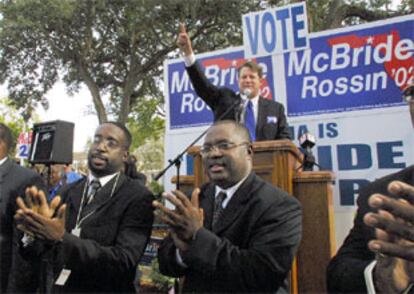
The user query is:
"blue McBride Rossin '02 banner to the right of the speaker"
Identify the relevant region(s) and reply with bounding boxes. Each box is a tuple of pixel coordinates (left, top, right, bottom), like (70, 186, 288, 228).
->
(284, 18, 414, 117)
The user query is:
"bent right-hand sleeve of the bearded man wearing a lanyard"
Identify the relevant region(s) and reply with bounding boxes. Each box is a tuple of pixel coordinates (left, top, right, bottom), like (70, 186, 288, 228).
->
(60, 190, 153, 281)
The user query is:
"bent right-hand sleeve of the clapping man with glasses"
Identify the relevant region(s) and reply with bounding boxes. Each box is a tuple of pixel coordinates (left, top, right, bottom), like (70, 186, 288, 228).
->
(183, 196, 302, 293)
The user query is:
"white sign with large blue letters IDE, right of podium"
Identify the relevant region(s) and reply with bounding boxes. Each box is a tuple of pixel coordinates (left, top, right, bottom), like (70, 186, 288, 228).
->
(290, 109, 414, 209)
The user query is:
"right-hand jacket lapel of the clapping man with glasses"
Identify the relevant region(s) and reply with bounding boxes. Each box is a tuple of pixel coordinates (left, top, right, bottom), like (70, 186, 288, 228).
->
(214, 172, 260, 234)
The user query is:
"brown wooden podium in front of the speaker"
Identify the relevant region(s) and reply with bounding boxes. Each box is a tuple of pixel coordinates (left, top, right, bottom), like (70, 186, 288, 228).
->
(173, 140, 335, 293)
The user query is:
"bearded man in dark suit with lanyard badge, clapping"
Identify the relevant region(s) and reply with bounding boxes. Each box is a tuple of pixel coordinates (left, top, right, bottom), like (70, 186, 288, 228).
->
(16, 122, 153, 293)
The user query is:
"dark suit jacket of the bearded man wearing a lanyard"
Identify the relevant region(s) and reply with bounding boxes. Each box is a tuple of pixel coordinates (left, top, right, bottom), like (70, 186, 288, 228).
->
(50, 174, 153, 293)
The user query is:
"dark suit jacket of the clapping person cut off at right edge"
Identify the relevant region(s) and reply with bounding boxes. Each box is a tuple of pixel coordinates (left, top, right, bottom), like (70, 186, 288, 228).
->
(327, 166, 414, 293)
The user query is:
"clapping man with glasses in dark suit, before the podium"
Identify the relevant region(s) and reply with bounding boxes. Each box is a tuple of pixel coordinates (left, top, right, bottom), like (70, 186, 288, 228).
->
(154, 120, 302, 293)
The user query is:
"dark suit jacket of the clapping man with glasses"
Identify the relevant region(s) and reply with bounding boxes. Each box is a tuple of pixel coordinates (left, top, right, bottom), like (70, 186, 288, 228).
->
(158, 173, 302, 293)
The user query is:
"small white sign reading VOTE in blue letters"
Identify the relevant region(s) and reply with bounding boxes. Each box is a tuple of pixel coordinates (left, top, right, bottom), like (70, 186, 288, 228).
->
(242, 2, 309, 57)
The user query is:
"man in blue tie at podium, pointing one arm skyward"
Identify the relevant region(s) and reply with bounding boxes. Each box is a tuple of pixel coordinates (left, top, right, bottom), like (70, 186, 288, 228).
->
(177, 24, 291, 141)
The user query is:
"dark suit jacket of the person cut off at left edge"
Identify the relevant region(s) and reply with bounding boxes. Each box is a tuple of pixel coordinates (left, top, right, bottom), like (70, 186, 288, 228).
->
(0, 159, 45, 293)
